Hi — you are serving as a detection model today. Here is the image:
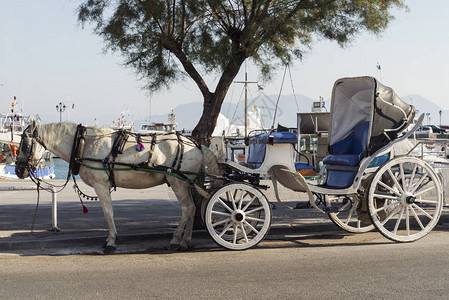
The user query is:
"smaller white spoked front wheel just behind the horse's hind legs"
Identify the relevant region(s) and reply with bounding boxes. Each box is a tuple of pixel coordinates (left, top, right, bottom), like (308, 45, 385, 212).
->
(204, 183, 271, 250)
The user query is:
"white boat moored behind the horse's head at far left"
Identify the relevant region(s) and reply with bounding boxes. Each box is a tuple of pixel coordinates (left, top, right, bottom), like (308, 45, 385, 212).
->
(0, 97, 55, 179)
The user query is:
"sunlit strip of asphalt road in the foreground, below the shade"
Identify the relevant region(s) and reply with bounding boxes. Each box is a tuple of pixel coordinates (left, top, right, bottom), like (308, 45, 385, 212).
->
(0, 230, 449, 299)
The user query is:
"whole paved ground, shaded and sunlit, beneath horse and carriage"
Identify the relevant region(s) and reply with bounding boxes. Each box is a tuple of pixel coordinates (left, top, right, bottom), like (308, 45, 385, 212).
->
(0, 182, 449, 299)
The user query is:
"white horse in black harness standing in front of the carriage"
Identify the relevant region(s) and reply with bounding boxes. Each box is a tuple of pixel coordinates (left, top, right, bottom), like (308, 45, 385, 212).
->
(16, 122, 221, 254)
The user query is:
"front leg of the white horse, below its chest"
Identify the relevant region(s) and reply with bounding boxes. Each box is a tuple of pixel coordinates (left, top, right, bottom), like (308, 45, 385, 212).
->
(94, 185, 117, 254)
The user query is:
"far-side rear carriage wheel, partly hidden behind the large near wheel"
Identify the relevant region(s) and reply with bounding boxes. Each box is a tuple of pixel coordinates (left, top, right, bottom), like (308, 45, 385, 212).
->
(324, 196, 374, 233)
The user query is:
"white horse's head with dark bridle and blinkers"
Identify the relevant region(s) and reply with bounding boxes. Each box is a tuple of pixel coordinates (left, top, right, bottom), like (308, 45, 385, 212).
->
(16, 122, 45, 179)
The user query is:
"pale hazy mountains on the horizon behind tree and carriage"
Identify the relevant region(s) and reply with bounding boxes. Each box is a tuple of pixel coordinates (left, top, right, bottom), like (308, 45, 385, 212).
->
(140, 93, 449, 130)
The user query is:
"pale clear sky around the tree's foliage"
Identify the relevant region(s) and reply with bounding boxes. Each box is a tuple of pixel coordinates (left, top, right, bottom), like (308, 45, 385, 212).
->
(0, 0, 449, 125)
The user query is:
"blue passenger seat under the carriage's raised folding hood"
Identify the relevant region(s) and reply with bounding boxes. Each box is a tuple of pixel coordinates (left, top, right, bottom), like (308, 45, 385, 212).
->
(323, 121, 369, 188)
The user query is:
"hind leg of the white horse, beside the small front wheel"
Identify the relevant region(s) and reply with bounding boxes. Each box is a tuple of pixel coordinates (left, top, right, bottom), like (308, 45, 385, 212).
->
(168, 178, 195, 251)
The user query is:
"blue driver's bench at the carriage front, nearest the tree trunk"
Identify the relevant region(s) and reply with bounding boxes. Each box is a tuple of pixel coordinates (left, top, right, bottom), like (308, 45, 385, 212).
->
(245, 132, 297, 169)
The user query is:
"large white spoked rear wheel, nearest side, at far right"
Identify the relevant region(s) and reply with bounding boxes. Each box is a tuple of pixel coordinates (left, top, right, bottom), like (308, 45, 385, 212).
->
(368, 157, 443, 242)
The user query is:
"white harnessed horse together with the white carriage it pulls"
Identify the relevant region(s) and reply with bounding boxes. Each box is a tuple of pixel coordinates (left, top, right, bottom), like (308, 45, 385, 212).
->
(16, 77, 443, 253)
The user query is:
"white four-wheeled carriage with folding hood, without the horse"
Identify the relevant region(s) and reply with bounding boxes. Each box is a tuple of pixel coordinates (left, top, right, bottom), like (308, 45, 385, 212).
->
(205, 77, 443, 250)
